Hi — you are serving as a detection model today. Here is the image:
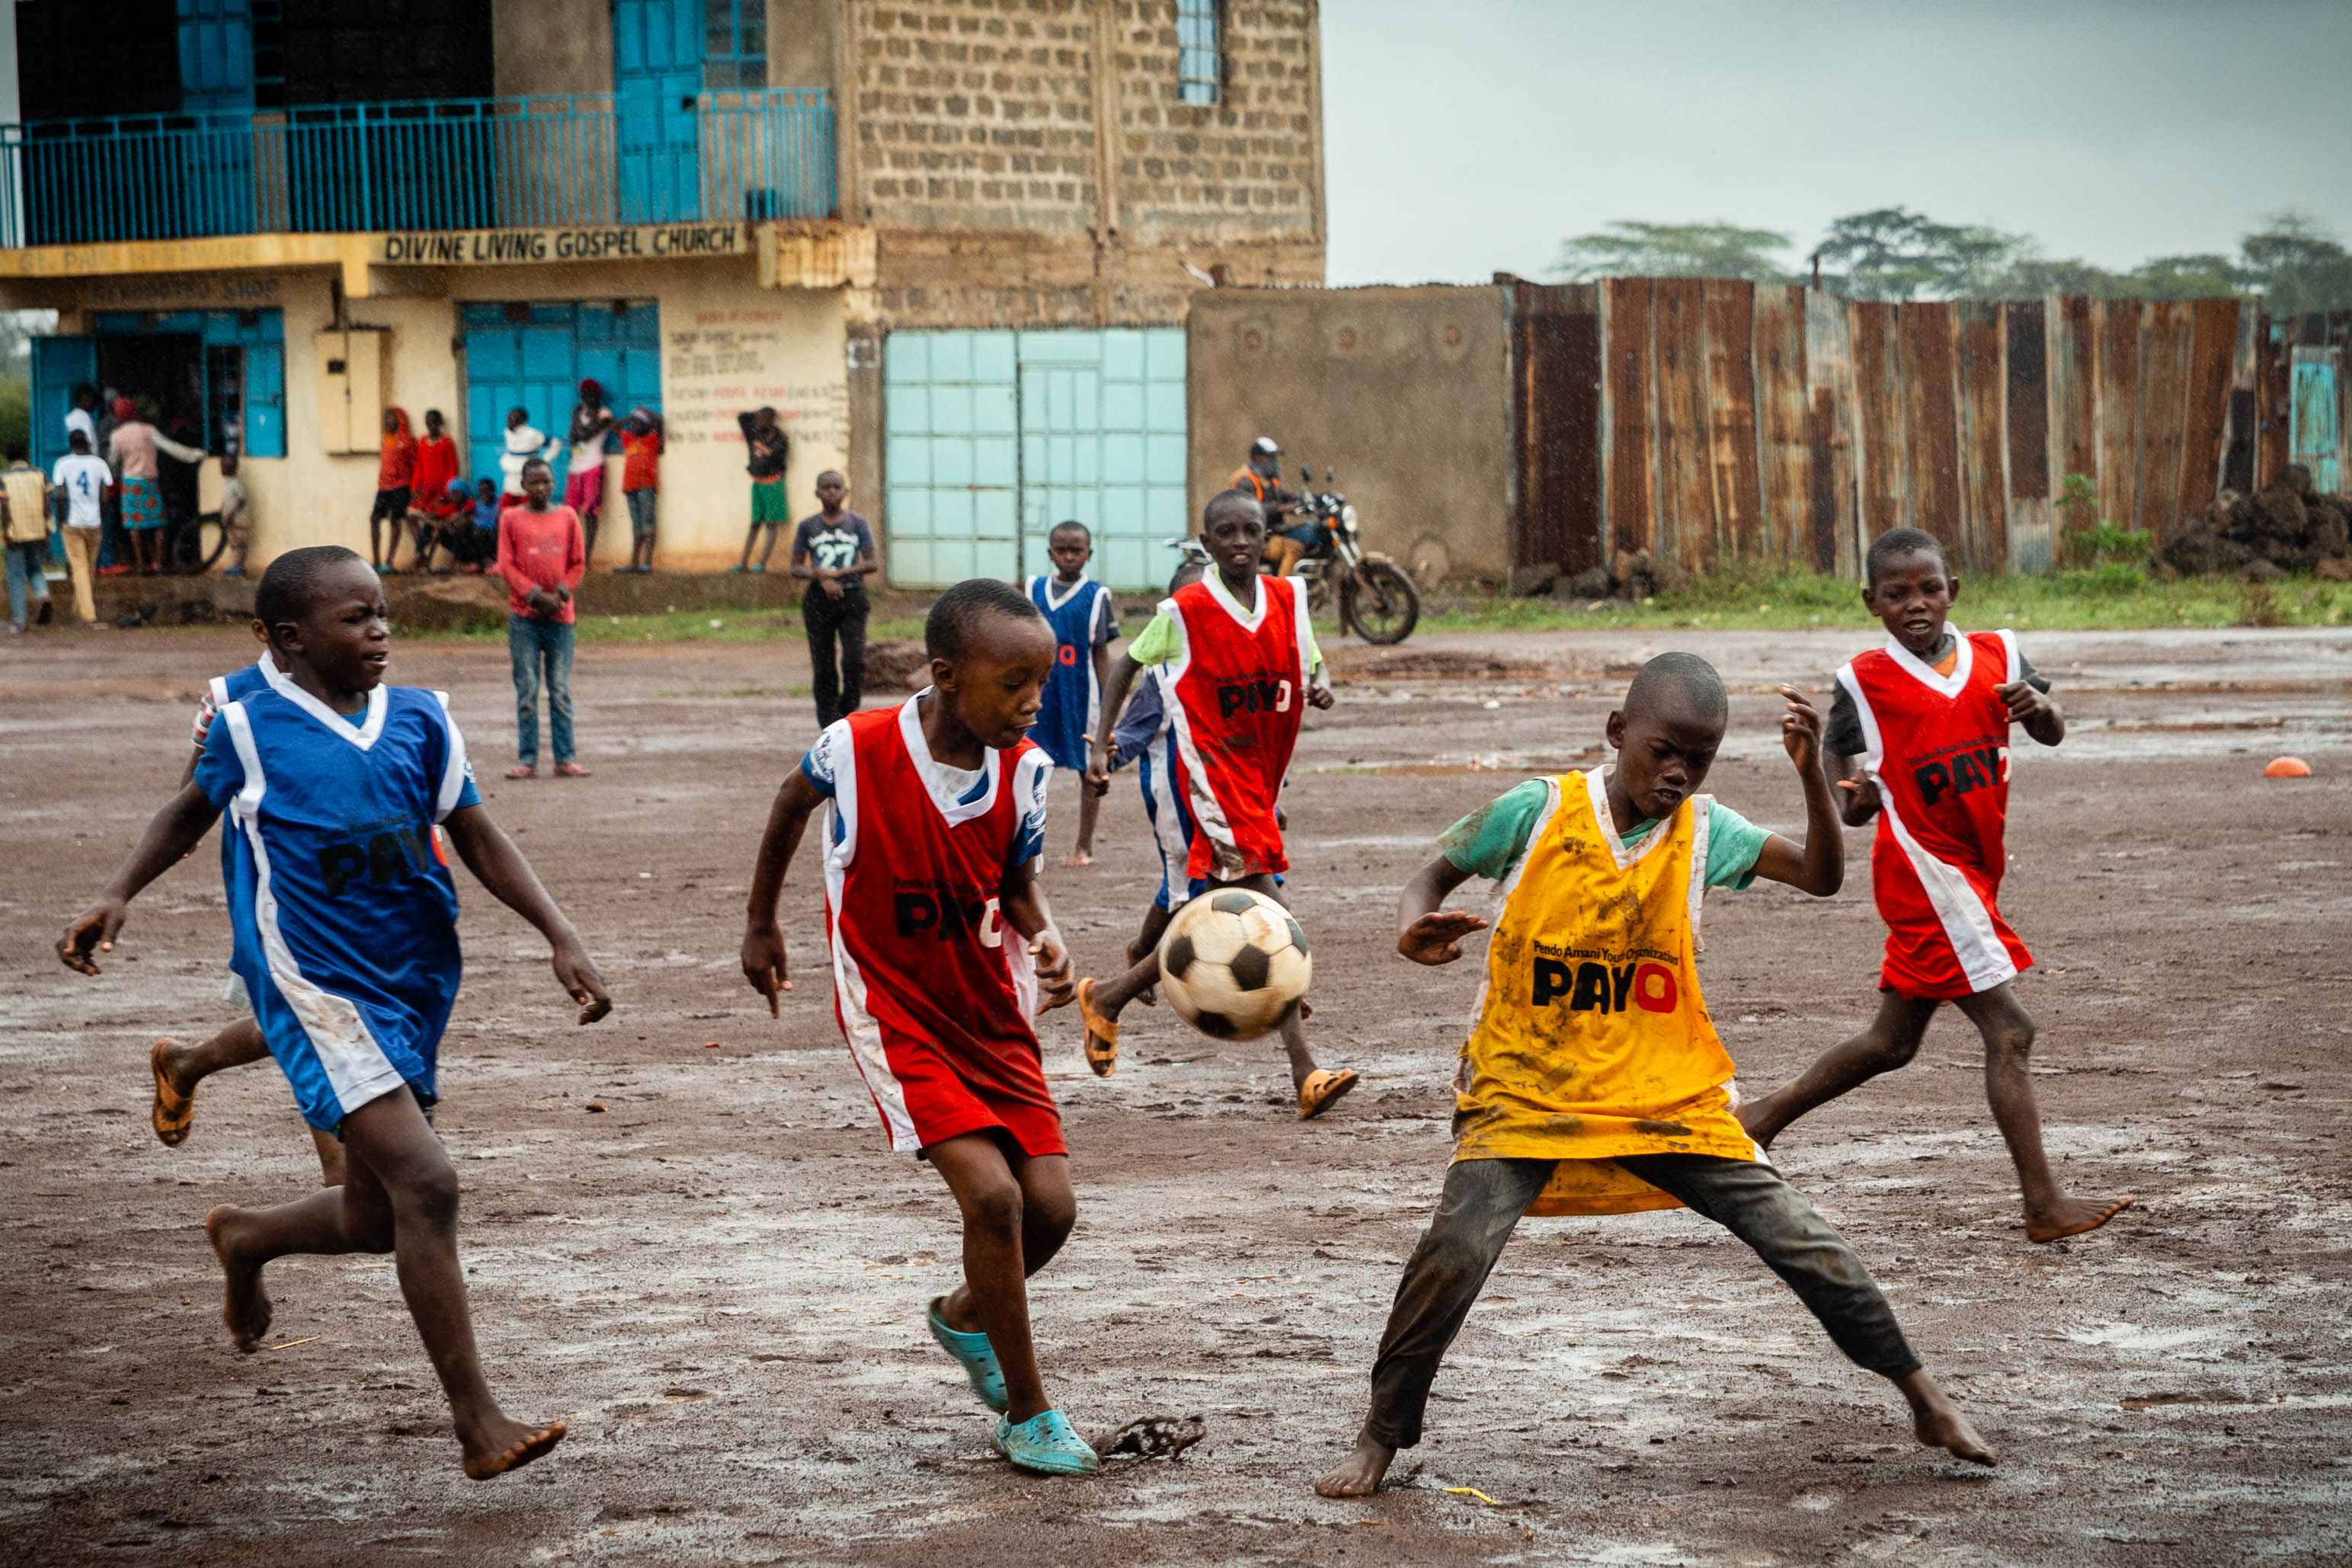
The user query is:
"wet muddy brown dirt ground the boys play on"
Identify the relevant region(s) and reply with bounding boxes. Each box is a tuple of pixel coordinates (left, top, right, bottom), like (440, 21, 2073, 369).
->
(0, 632, 2352, 1568)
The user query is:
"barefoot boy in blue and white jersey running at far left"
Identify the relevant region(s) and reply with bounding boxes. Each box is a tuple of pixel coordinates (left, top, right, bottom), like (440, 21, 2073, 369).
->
(56, 546, 612, 1479)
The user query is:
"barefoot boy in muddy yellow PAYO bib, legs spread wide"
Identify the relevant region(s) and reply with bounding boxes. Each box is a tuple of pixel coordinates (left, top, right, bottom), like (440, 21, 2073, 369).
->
(1315, 654, 1995, 1497)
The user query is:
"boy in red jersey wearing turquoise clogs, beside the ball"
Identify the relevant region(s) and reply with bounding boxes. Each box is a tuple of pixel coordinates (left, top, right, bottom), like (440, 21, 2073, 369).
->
(743, 581, 1101, 1474)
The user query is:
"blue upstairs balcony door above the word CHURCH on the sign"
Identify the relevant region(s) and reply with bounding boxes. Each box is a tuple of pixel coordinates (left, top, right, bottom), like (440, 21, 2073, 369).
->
(612, 0, 703, 223)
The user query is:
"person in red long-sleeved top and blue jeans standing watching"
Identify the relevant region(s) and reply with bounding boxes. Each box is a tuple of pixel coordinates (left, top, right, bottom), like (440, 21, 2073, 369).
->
(498, 459, 588, 778)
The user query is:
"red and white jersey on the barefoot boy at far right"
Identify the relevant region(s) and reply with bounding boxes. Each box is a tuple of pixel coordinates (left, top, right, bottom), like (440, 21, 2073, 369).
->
(1837, 630, 2032, 999)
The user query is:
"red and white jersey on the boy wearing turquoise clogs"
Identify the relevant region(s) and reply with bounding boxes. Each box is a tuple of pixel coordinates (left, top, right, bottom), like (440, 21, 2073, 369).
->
(802, 698, 1065, 1154)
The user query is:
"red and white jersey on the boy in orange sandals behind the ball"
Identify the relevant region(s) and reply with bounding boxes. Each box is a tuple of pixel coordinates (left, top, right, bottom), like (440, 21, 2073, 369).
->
(1160, 571, 1315, 882)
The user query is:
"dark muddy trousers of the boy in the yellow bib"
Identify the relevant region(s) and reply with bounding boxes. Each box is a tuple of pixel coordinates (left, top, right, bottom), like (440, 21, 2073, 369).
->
(1364, 1154, 1919, 1448)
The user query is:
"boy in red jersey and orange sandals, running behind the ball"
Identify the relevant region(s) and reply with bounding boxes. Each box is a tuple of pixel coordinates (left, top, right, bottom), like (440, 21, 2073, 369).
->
(1077, 489, 1355, 1119)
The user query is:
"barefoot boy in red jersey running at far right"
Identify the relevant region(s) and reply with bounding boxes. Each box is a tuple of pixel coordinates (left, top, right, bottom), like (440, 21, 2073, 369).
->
(1740, 529, 2131, 1241)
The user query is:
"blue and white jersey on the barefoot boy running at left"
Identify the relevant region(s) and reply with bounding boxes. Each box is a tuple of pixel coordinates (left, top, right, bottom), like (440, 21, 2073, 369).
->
(195, 680, 482, 1133)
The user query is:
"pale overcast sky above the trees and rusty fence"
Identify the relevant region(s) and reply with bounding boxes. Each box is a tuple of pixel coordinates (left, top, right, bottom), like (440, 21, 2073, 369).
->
(1322, 0, 2352, 284)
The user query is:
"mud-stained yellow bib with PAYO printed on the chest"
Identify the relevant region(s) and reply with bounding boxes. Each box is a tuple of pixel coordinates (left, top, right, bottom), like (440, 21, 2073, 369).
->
(1454, 769, 1762, 1213)
